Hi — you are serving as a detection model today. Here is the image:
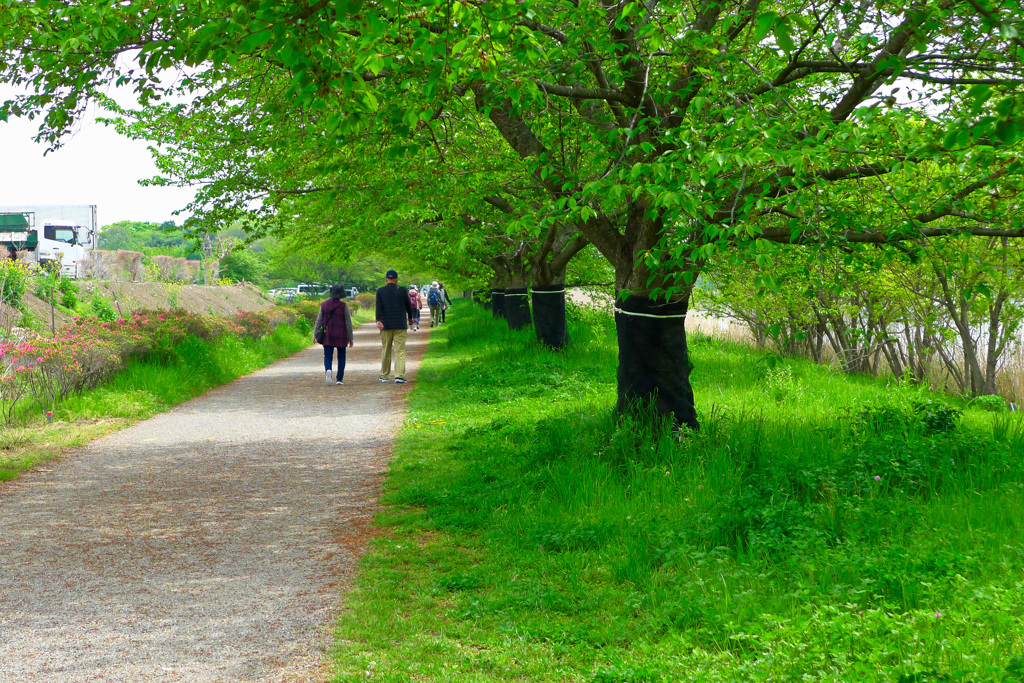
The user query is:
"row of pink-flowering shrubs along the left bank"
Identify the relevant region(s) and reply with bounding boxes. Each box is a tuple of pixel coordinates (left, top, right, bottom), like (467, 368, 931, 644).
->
(0, 309, 275, 425)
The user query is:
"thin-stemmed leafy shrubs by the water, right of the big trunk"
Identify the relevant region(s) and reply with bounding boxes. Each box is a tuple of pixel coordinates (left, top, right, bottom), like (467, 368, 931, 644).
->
(694, 238, 1024, 399)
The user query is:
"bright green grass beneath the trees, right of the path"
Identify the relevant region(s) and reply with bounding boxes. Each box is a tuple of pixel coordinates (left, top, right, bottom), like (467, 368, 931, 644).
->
(335, 304, 1024, 683)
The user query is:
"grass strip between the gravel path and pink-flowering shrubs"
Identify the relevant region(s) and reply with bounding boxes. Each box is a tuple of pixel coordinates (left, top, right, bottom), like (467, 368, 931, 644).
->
(0, 318, 311, 481)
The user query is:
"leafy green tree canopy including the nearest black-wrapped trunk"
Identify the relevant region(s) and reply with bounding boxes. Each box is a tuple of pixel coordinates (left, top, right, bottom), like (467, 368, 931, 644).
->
(0, 0, 1024, 427)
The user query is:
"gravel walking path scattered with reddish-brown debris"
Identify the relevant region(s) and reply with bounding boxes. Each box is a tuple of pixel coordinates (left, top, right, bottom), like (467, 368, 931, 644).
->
(0, 325, 426, 683)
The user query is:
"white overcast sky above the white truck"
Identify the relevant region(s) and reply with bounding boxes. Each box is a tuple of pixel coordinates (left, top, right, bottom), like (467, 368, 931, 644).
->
(0, 80, 195, 225)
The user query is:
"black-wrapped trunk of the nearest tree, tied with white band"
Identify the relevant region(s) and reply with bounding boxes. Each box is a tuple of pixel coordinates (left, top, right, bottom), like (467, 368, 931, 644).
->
(615, 295, 698, 429)
